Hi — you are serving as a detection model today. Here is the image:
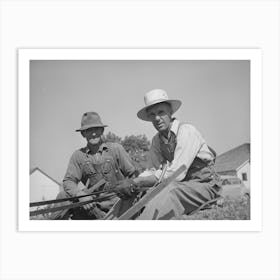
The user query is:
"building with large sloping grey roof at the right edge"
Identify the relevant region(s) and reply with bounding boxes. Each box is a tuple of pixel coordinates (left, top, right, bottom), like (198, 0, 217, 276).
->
(215, 143, 250, 189)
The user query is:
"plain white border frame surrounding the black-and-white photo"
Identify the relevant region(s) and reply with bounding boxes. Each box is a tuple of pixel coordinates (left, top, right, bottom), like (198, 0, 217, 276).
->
(18, 49, 262, 231)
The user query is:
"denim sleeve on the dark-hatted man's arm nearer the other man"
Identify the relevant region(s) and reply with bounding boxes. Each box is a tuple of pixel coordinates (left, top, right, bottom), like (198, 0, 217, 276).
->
(114, 143, 136, 177)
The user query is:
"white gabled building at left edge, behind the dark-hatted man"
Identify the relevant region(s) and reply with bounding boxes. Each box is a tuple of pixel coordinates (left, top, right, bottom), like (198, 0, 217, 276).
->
(30, 167, 61, 202)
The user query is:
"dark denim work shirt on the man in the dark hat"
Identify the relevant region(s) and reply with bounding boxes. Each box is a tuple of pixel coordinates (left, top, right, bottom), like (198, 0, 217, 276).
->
(63, 142, 136, 196)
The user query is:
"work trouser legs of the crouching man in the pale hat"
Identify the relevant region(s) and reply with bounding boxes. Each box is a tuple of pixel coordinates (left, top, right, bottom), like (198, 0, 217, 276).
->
(106, 165, 221, 220)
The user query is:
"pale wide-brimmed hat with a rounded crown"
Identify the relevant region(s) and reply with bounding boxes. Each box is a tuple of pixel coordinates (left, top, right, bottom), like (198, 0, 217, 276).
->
(137, 89, 182, 121)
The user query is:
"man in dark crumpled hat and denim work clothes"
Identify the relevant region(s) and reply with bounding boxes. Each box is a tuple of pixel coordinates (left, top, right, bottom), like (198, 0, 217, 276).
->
(51, 112, 136, 219)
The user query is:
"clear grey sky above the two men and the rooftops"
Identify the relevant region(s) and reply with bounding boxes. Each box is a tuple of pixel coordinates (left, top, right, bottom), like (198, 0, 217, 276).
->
(30, 60, 250, 182)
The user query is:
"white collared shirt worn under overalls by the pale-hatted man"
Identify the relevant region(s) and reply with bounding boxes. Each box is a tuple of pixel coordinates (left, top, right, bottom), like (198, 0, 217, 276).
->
(150, 119, 214, 181)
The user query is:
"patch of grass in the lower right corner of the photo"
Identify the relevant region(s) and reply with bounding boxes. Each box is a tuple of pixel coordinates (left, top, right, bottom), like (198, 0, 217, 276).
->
(182, 196, 250, 220)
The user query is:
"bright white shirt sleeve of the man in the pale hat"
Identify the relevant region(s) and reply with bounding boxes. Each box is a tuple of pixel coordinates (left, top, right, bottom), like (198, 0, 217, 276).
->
(155, 125, 203, 181)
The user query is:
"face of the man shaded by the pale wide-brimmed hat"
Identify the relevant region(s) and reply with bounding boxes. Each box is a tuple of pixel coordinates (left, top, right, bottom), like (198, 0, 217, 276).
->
(147, 103, 172, 133)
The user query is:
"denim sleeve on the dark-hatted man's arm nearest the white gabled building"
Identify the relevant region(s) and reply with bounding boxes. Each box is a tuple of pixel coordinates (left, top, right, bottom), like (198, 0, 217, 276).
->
(63, 151, 82, 196)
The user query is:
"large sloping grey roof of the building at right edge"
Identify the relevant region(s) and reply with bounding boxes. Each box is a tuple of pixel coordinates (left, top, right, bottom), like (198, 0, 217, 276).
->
(215, 143, 250, 172)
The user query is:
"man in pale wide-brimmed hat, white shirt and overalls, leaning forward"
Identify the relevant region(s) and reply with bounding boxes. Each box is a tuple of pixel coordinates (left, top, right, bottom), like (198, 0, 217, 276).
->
(112, 89, 220, 220)
